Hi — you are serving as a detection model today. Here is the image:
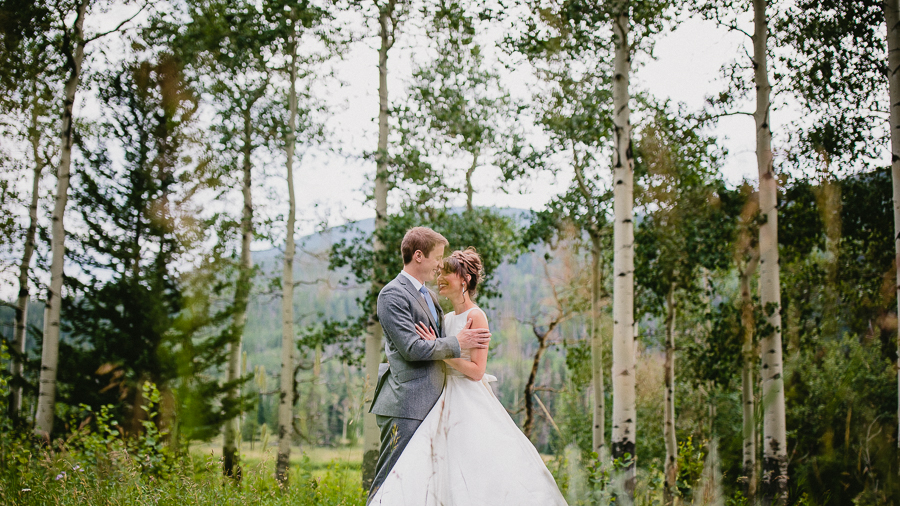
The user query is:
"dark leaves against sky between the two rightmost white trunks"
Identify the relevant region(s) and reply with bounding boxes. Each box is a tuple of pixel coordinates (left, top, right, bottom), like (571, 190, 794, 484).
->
(772, 0, 889, 171)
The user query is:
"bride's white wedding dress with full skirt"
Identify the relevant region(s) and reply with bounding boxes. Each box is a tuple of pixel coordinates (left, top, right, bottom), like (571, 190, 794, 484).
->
(369, 308, 566, 506)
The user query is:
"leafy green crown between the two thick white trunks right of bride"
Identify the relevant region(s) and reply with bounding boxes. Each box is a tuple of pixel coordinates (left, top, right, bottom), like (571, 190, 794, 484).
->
(635, 102, 736, 310)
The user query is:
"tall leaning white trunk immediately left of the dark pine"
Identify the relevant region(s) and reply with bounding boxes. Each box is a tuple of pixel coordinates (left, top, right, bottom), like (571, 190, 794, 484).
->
(34, 0, 88, 438)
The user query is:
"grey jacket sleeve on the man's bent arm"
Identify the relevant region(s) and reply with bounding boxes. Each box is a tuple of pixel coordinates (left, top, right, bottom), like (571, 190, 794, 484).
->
(378, 290, 460, 362)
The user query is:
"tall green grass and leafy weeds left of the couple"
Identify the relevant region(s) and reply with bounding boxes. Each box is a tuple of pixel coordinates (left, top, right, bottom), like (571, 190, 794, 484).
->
(0, 385, 365, 506)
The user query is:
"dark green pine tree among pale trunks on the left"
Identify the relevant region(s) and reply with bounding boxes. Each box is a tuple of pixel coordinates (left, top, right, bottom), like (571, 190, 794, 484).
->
(60, 54, 229, 434)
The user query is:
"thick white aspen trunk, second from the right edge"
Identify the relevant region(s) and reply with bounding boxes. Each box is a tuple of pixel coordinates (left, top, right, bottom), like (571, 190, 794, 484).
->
(753, 0, 787, 504)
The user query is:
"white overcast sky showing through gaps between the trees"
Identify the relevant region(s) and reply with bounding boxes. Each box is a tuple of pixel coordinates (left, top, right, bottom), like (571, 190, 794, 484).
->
(0, 7, 880, 298)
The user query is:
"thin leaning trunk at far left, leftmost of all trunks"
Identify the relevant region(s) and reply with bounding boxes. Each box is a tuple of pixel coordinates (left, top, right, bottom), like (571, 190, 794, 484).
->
(9, 80, 44, 420)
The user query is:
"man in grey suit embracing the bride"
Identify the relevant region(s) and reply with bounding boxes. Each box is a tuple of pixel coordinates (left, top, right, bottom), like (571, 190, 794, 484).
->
(369, 227, 491, 498)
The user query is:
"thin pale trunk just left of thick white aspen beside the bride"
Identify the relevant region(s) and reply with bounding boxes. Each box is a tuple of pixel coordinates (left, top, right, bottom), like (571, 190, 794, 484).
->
(591, 237, 606, 459)
